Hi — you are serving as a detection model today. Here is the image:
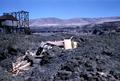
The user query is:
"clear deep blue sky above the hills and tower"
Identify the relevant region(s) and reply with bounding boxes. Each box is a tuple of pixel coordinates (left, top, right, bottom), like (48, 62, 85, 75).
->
(0, 0, 120, 19)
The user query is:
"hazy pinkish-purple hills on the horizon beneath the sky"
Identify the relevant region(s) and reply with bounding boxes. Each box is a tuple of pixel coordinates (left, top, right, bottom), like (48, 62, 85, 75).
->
(30, 17, 120, 27)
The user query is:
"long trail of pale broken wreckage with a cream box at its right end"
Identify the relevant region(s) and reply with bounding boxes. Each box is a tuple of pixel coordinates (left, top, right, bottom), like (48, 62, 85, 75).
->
(12, 37, 78, 75)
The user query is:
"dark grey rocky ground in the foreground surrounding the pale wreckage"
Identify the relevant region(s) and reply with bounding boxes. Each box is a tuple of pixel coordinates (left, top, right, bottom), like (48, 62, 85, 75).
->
(0, 33, 120, 81)
